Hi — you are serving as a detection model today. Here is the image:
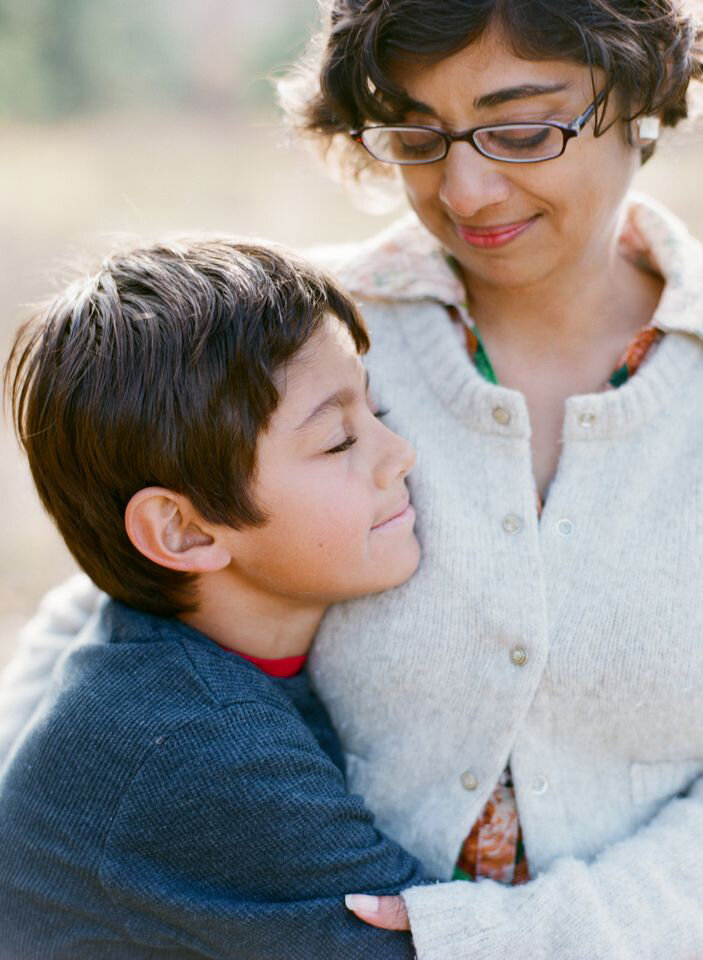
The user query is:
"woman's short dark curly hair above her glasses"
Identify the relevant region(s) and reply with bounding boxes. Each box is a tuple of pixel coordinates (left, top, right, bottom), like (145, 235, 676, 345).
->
(279, 0, 703, 176)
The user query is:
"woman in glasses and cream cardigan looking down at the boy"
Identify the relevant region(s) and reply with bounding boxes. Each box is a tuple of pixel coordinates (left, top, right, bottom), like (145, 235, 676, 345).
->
(4, 0, 703, 960)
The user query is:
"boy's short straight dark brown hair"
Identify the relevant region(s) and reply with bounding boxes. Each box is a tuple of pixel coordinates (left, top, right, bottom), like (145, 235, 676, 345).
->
(4, 239, 369, 616)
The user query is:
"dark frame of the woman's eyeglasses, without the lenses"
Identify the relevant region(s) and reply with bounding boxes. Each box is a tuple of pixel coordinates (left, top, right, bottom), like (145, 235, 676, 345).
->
(349, 90, 607, 167)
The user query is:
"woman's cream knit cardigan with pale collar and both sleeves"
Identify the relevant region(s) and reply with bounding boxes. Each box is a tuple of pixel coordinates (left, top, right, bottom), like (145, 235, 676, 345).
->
(0, 201, 703, 960)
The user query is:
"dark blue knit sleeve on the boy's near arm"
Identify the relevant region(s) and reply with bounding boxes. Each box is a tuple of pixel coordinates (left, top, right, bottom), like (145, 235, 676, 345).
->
(100, 702, 423, 960)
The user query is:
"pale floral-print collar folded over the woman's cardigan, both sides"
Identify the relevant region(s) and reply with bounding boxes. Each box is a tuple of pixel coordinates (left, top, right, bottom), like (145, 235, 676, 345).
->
(335, 194, 703, 339)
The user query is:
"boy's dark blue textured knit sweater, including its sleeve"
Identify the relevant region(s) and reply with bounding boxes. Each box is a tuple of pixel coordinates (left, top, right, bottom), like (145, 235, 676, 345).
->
(0, 602, 423, 960)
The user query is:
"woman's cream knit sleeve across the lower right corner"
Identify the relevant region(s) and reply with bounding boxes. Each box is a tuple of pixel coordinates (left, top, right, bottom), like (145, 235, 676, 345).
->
(403, 780, 703, 960)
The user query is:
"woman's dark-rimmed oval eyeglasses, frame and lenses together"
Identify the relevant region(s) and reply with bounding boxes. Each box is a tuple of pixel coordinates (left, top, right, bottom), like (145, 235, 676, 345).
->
(349, 90, 606, 166)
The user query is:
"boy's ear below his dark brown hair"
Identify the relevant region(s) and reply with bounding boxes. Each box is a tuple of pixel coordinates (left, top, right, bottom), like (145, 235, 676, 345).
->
(125, 487, 232, 573)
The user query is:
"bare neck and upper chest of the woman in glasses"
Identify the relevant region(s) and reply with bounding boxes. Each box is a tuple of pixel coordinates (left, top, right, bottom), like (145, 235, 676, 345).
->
(467, 240, 663, 495)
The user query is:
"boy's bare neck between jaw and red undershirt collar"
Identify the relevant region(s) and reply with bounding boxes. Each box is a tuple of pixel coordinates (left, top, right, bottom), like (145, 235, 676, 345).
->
(180, 571, 326, 660)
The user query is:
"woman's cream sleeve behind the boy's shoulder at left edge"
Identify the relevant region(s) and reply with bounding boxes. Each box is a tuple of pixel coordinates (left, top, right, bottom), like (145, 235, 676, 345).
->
(0, 573, 104, 765)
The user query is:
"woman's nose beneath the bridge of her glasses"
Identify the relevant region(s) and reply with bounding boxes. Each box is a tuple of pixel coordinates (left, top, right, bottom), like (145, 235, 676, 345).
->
(439, 143, 510, 219)
